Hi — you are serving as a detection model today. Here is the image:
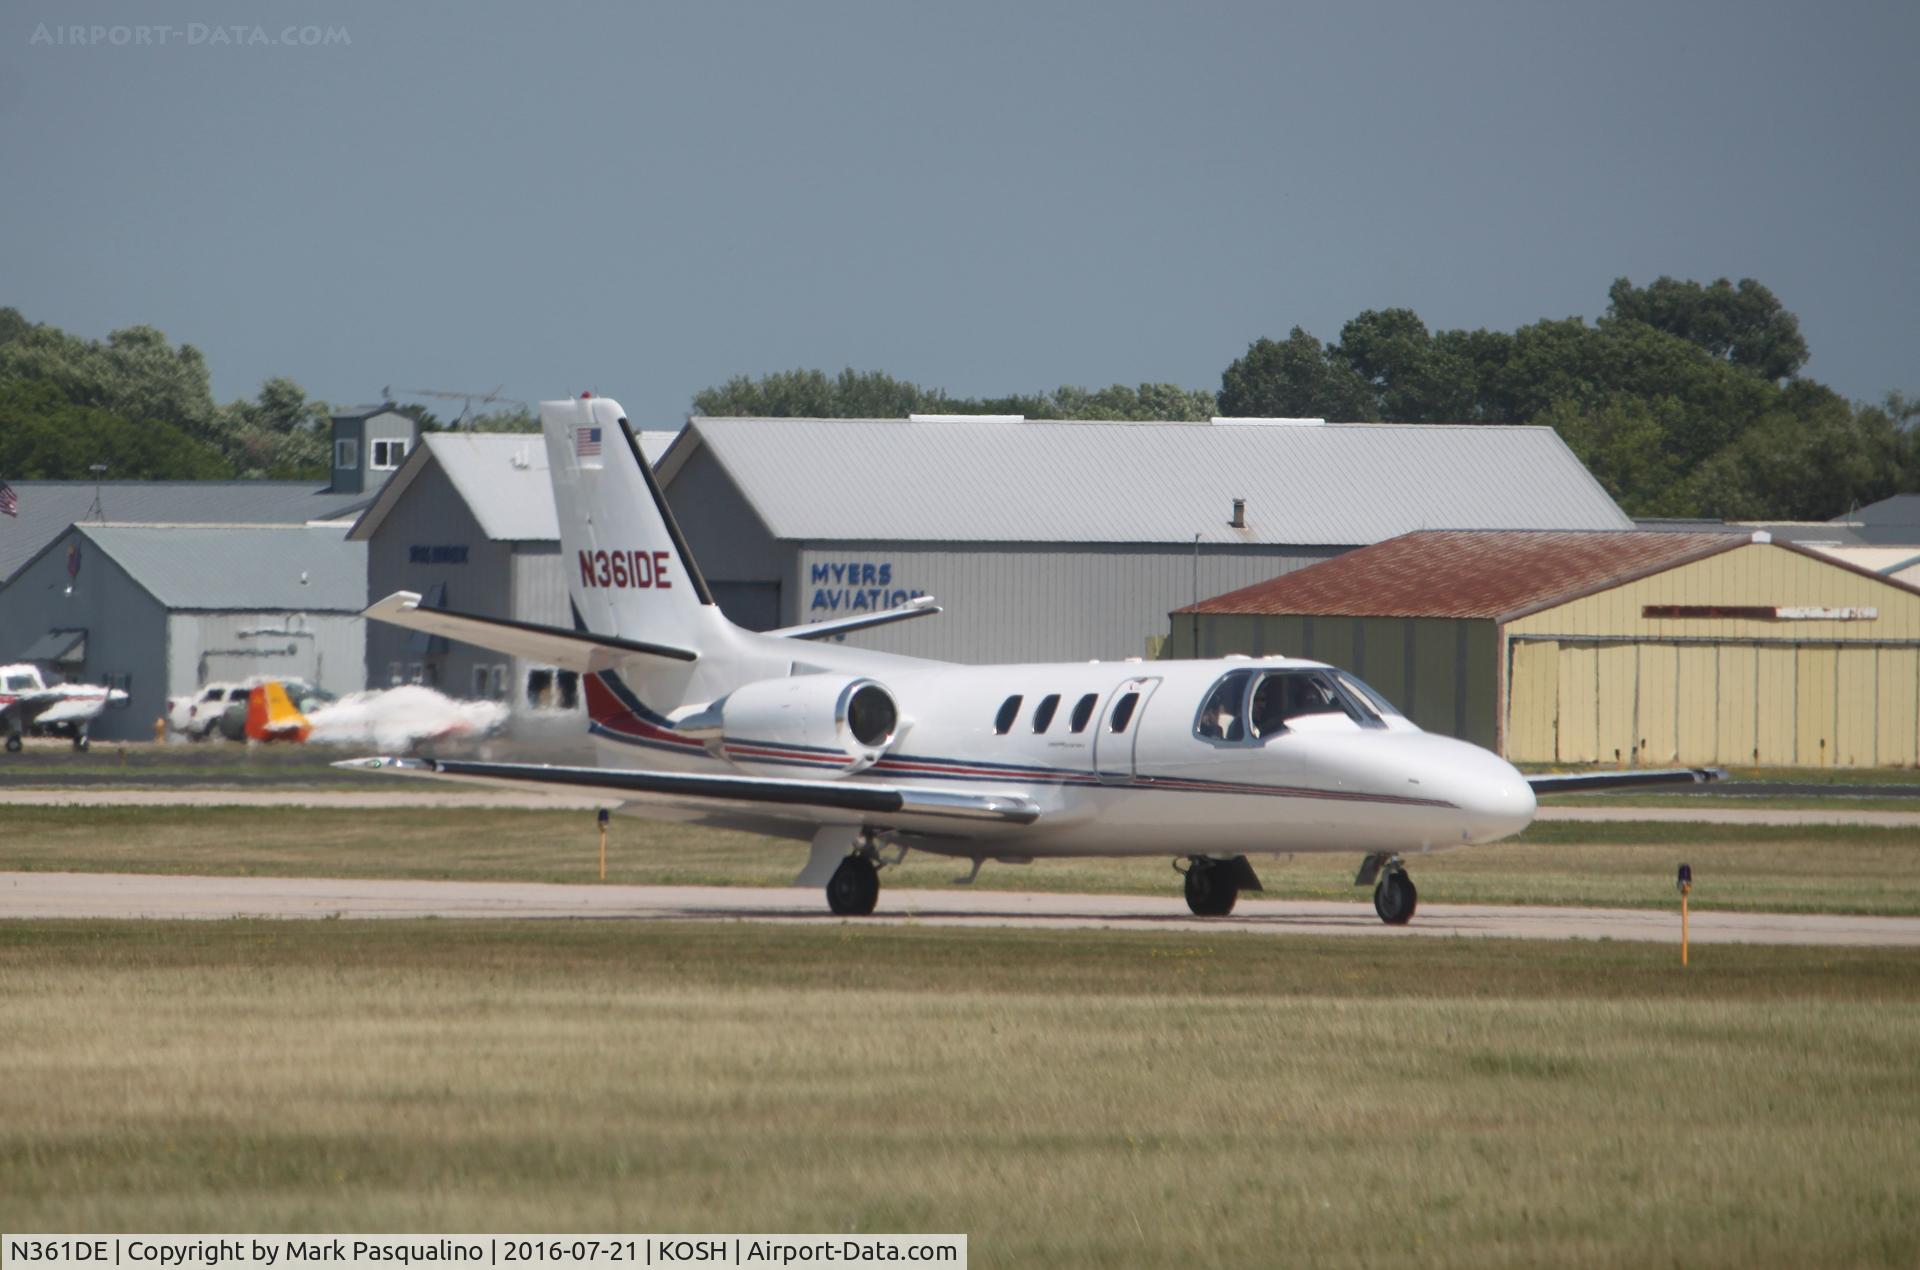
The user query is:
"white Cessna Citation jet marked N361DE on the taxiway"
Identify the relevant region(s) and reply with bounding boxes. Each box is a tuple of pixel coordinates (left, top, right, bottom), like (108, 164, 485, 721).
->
(340, 396, 1716, 924)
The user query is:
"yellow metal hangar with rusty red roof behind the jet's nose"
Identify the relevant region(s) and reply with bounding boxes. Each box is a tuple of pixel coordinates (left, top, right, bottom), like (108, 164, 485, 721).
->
(1165, 530, 1920, 767)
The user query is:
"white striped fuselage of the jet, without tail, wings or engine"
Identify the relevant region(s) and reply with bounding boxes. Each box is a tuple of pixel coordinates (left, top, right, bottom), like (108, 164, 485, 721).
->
(589, 628, 1534, 859)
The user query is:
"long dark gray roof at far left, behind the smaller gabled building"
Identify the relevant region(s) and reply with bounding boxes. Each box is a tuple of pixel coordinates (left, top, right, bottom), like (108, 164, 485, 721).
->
(0, 480, 372, 582)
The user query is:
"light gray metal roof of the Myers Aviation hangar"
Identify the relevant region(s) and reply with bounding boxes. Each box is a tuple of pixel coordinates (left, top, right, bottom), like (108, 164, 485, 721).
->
(660, 417, 1634, 546)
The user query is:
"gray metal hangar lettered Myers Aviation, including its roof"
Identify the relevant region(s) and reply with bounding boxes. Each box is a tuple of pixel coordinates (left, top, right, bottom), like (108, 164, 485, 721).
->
(659, 417, 1632, 663)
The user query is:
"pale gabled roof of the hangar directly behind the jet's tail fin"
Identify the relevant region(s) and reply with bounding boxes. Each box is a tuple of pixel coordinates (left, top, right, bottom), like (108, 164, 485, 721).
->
(353, 432, 678, 542)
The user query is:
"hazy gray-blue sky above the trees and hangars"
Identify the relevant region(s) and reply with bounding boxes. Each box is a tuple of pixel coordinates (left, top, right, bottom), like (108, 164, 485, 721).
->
(0, 0, 1920, 425)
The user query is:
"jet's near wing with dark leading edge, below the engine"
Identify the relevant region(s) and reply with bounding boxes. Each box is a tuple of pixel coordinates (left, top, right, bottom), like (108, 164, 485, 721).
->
(334, 757, 1041, 834)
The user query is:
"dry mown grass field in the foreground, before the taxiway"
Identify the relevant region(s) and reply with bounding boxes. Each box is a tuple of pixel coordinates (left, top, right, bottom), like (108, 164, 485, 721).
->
(0, 922, 1920, 1266)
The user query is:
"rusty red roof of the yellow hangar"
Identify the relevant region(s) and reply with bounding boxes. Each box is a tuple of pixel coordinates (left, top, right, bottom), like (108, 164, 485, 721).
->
(1179, 530, 1753, 621)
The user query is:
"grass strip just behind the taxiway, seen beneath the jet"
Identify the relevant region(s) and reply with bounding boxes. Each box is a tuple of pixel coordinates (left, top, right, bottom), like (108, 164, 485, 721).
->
(0, 807, 1920, 915)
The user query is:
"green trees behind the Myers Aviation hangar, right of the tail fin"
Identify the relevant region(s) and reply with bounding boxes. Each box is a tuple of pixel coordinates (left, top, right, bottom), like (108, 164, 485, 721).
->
(693, 277, 1920, 521)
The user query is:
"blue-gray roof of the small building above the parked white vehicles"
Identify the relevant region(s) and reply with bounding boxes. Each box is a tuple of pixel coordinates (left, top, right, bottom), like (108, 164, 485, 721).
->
(75, 525, 367, 613)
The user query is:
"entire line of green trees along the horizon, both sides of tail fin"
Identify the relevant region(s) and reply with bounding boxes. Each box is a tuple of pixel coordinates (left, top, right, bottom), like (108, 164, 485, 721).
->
(0, 277, 1920, 519)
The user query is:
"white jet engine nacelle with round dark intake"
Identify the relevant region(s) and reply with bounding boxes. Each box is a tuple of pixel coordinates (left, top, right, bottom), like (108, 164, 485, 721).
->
(714, 674, 900, 772)
